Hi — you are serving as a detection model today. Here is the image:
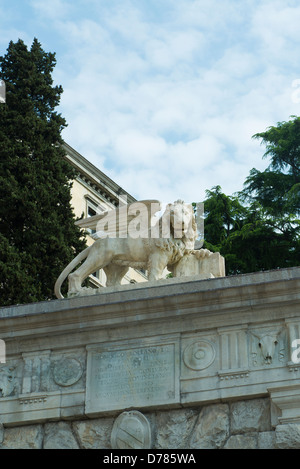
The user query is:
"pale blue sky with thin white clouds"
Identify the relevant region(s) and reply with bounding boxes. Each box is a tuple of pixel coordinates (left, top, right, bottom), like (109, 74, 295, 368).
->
(0, 0, 300, 202)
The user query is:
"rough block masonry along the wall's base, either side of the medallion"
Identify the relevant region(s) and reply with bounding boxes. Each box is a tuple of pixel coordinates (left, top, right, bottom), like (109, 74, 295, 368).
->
(0, 398, 300, 450)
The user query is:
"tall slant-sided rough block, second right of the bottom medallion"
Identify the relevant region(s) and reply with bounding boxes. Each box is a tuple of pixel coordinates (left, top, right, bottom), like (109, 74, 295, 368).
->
(190, 404, 229, 449)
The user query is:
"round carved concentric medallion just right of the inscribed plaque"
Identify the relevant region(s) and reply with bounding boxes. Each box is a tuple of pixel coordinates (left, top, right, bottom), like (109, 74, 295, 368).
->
(183, 340, 216, 371)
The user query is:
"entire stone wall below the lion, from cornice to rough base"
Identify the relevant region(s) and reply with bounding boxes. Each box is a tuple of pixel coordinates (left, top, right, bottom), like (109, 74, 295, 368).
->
(0, 268, 300, 450)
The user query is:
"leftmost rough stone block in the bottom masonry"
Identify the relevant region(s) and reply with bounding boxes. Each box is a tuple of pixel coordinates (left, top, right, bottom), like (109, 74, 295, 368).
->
(0, 425, 43, 449)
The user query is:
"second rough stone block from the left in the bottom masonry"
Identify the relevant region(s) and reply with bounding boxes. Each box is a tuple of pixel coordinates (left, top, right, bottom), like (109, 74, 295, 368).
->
(43, 422, 79, 449)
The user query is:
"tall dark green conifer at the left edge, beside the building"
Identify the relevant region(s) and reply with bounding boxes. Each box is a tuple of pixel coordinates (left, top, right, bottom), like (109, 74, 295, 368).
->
(0, 39, 85, 306)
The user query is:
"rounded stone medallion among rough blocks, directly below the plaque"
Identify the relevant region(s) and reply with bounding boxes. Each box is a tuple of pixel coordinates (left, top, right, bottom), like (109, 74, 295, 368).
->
(111, 410, 151, 449)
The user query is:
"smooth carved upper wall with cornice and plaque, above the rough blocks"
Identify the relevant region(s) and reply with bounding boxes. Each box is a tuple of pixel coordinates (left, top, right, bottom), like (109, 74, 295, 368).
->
(0, 268, 300, 428)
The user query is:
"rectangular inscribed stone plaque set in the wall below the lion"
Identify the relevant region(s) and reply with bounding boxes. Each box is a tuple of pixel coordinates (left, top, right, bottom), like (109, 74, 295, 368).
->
(86, 339, 179, 413)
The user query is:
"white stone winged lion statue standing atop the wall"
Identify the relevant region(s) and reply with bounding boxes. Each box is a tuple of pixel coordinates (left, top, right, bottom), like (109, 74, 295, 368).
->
(54, 200, 206, 298)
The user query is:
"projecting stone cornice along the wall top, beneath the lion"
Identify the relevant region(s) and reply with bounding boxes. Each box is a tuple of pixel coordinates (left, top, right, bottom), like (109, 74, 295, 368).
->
(0, 268, 300, 339)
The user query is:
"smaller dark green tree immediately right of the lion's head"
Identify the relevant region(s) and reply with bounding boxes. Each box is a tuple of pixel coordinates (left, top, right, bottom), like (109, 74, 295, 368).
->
(203, 186, 283, 275)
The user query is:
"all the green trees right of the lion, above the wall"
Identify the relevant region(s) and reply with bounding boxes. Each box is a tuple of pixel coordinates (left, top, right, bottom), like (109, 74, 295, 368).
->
(204, 116, 300, 275)
